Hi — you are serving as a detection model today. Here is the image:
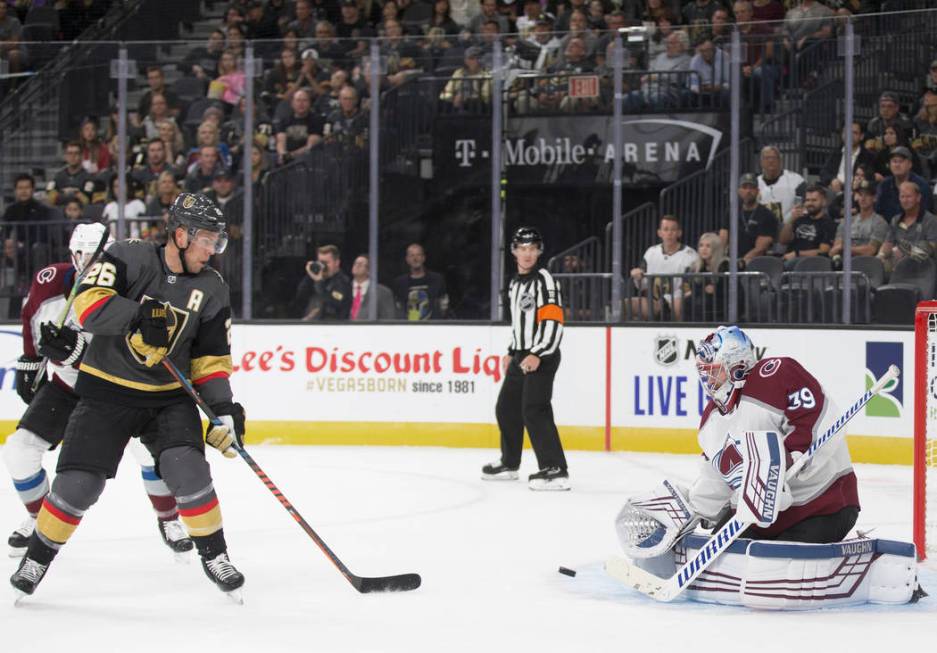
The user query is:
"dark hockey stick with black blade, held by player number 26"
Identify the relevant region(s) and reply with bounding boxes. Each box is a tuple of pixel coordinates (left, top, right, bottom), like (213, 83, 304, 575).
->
(163, 358, 421, 594)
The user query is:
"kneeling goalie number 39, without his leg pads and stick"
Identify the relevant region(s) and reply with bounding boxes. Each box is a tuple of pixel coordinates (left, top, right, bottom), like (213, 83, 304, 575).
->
(618, 326, 859, 549)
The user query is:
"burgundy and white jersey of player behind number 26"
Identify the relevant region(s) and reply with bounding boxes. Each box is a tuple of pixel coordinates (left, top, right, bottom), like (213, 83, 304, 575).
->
(22, 263, 82, 389)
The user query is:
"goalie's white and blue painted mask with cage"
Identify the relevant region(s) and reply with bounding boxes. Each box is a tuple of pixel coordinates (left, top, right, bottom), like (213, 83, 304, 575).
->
(696, 326, 755, 411)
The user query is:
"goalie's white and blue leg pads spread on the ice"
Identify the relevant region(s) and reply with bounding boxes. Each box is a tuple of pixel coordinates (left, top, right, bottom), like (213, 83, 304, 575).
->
(674, 535, 918, 610)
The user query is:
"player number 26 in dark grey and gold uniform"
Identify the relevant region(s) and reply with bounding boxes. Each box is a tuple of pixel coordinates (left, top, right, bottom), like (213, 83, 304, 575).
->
(10, 193, 244, 596)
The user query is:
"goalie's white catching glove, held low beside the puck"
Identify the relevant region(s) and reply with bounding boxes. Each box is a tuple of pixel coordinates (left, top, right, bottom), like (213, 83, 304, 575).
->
(615, 480, 700, 558)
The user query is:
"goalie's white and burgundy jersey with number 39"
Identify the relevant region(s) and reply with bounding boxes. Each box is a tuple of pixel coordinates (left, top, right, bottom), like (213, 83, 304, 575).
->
(690, 357, 859, 536)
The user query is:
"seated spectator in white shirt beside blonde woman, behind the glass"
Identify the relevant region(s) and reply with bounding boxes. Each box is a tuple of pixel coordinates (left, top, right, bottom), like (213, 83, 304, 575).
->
(631, 215, 699, 320)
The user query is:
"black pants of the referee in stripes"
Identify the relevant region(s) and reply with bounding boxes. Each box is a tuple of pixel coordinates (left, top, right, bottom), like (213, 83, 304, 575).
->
(495, 352, 566, 470)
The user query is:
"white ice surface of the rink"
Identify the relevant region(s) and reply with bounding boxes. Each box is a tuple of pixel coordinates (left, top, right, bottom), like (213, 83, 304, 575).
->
(0, 446, 937, 653)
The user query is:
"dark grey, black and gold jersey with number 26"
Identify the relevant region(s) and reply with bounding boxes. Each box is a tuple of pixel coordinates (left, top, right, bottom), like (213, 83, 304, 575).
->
(74, 240, 231, 406)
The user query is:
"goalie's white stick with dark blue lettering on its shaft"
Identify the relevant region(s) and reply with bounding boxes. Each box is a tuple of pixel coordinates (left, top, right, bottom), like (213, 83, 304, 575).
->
(605, 365, 901, 601)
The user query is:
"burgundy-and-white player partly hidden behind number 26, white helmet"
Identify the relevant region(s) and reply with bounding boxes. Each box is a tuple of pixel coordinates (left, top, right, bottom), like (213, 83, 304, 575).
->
(3, 224, 193, 557)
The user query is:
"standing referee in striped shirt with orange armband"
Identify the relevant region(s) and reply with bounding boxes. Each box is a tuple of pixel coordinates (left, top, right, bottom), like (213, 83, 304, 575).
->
(482, 227, 569, 490)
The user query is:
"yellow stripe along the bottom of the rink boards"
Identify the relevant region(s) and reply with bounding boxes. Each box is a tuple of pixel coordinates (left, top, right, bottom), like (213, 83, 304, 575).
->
(0, 420, 914, 465)
